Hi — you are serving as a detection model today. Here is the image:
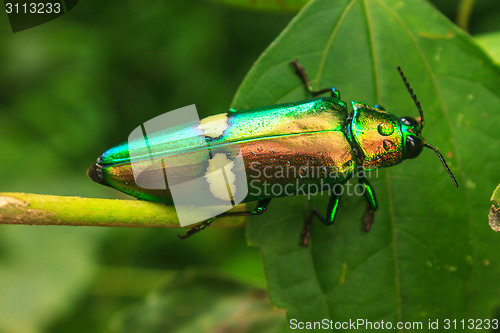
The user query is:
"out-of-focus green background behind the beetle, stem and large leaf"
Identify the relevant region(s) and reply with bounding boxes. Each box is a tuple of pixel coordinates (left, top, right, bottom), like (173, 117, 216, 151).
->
(0, 0, 500, 333)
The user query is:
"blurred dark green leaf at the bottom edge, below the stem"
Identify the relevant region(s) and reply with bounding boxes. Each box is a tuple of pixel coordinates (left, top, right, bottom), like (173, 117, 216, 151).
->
(111, 271, 286, 333)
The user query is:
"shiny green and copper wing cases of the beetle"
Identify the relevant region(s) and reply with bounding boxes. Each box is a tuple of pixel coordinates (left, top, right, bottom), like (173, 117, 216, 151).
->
(89, 97, 356, 203)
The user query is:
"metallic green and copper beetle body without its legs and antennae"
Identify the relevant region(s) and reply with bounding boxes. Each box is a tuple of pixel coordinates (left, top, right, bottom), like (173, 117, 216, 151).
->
(89, 96, 426, 203)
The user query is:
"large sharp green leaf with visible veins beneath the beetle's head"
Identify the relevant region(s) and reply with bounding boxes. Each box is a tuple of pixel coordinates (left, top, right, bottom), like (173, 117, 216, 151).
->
(233, 0, 500, 327)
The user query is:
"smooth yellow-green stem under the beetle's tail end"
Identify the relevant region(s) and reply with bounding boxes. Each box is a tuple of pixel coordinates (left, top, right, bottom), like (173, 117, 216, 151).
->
(0, 192, 246, 228)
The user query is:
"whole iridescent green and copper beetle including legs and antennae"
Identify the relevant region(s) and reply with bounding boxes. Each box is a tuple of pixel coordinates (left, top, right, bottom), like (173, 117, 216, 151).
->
(88, 60, 458, 240)
